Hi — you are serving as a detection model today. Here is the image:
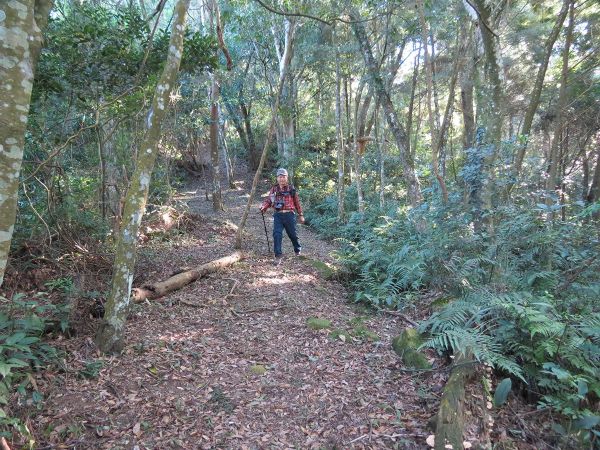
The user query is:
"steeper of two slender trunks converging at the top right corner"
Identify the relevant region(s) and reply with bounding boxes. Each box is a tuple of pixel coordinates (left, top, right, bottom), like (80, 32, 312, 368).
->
(546, 0, 575, 220)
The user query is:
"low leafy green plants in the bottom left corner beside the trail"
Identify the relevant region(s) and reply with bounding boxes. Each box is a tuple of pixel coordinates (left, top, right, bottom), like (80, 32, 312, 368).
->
(0, 294, 68, 435)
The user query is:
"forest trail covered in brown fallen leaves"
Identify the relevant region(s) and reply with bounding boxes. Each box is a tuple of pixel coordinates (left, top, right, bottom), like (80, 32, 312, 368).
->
(30, 171, 436, 449)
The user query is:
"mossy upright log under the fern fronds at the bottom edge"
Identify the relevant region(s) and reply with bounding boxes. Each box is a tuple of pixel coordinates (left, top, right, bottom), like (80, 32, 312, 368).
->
(435, 358, 475, 450)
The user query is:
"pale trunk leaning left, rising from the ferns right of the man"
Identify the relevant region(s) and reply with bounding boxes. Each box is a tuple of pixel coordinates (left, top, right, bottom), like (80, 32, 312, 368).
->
(349, 11, 422, 207)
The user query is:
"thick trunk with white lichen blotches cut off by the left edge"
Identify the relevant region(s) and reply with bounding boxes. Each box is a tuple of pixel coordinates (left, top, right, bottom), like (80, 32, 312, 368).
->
(0, 0, 52, 285)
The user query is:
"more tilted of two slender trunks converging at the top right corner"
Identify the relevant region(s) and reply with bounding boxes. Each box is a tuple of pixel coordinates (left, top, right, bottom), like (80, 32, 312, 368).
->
(513, 0, 571, 179)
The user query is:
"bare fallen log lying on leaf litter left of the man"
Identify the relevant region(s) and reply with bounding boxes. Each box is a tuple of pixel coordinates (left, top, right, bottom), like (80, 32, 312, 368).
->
(131, 252, 242, 302)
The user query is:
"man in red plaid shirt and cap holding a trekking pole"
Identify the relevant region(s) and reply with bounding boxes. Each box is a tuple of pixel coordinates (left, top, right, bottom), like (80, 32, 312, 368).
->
(260, 169, 304, 266)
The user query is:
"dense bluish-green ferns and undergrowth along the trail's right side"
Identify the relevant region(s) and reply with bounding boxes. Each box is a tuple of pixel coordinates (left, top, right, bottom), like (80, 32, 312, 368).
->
(313, 192, 600, 431)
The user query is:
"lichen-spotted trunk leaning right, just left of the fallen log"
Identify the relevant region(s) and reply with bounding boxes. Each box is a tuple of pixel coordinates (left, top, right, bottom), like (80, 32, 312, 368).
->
(96, 0, 190, 353)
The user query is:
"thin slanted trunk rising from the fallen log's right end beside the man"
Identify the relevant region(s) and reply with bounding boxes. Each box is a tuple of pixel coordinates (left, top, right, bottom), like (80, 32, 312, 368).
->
(235, 20, 296, 249)
